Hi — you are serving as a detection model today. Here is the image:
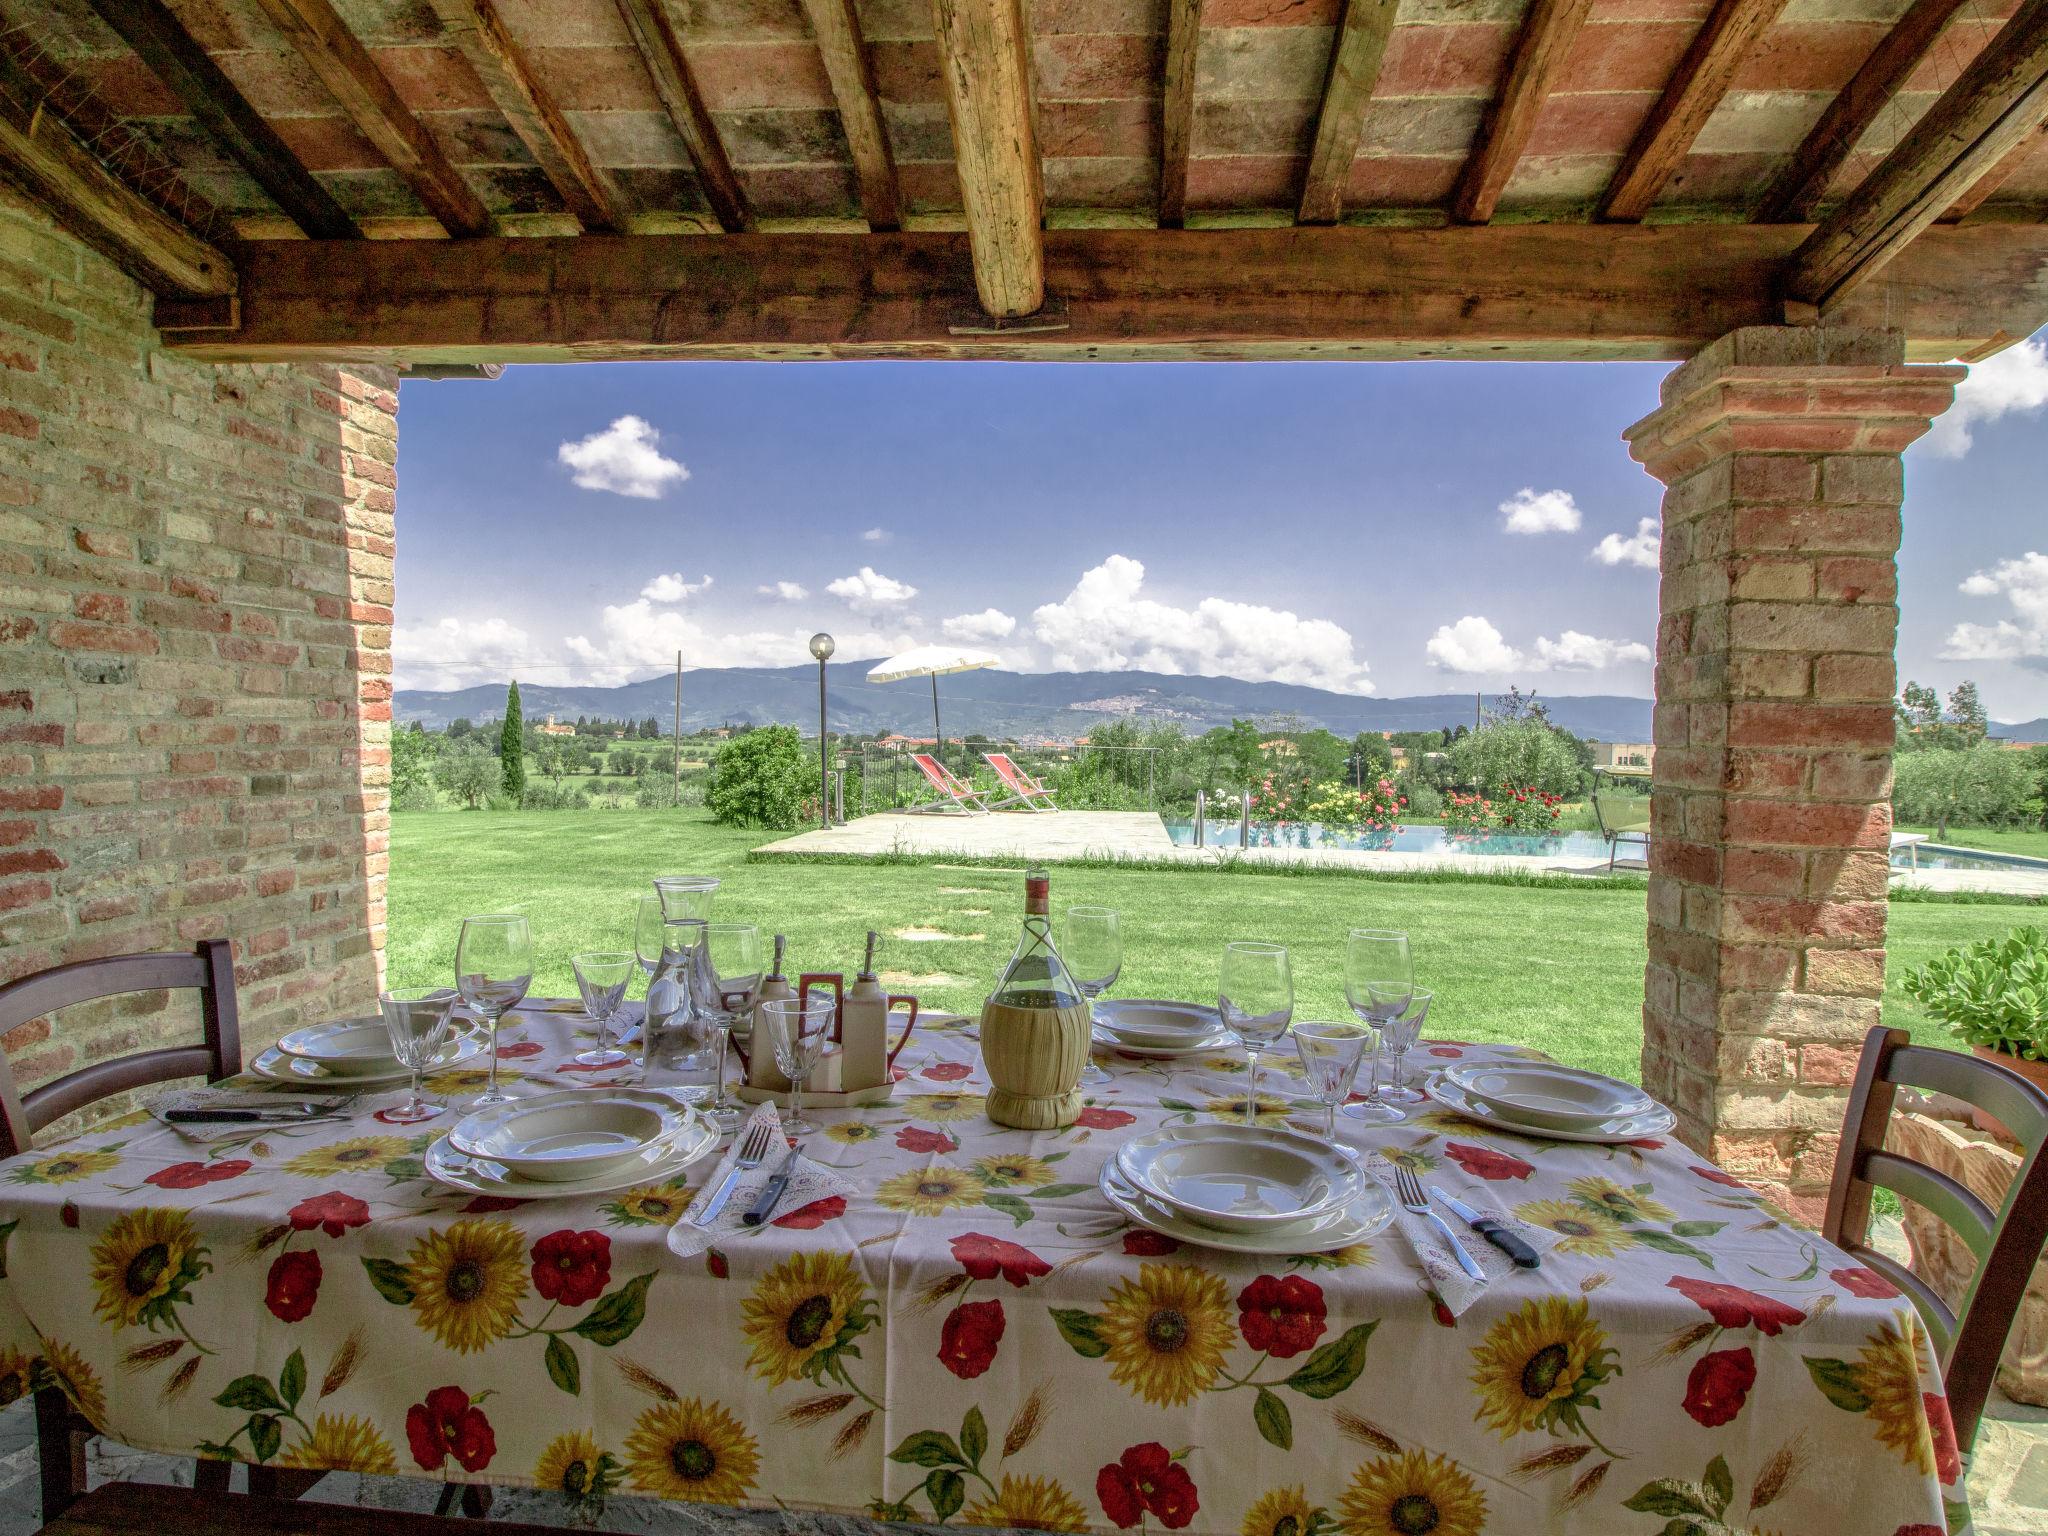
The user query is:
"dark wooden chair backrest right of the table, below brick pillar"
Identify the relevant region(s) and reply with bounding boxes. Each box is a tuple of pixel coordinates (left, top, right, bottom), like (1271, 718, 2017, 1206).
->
(1821, 1026, 2048, 1450)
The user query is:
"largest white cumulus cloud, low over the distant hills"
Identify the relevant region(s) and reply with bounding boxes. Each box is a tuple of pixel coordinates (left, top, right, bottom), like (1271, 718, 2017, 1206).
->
(1032, 555, 1372, 694)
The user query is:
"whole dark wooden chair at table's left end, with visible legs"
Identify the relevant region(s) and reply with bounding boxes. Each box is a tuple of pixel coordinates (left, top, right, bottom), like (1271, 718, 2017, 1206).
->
(0, 938, 242, 1520)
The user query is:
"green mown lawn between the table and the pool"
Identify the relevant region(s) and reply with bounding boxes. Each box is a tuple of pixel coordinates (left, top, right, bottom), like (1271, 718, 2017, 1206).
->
(389, 811, 2040, 1077)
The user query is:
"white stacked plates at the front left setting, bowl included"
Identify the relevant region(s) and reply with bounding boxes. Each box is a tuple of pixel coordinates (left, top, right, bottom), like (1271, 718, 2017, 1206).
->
(426, 1087, 719, 1200)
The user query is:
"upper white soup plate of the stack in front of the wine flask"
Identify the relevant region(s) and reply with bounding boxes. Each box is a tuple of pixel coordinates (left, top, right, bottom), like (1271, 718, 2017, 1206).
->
(1114, 1124, 1364, 1233)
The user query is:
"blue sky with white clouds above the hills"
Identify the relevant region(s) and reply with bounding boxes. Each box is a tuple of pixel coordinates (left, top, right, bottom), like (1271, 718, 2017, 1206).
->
(397, 340, 2048, 719)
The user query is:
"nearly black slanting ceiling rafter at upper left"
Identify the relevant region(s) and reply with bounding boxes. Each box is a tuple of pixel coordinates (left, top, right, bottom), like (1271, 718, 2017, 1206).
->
(80, 0, 360, 240)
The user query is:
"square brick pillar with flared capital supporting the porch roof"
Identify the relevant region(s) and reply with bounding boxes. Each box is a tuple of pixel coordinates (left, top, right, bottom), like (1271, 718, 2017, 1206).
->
(1626, 326, 1964, 1219)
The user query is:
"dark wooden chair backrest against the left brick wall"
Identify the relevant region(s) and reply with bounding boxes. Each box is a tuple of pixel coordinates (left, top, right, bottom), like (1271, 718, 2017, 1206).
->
(0, 938, 242, 1157)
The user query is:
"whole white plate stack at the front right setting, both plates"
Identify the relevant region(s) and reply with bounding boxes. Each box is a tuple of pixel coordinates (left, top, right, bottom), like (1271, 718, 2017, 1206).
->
(1102, 1124, 1393, 1253)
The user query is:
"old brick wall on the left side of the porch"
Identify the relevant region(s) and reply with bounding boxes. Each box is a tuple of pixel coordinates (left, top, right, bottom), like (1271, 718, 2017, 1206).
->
(0, 188, 397, 1114)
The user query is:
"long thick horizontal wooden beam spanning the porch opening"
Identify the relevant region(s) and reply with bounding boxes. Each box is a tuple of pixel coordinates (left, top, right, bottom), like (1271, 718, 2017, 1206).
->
(178, 223, 2048, 365)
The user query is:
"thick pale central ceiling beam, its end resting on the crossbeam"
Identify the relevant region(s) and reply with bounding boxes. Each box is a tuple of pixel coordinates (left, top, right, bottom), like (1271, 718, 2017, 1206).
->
(932, 0, 1044, 319)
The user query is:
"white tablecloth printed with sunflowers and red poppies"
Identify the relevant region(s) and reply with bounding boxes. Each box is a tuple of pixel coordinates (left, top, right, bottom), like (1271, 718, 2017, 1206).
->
(0, 1012, 1960, 1536)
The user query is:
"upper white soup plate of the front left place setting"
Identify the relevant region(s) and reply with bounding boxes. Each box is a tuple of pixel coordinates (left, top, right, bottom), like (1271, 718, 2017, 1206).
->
(449, 1087, 694, 1184)
